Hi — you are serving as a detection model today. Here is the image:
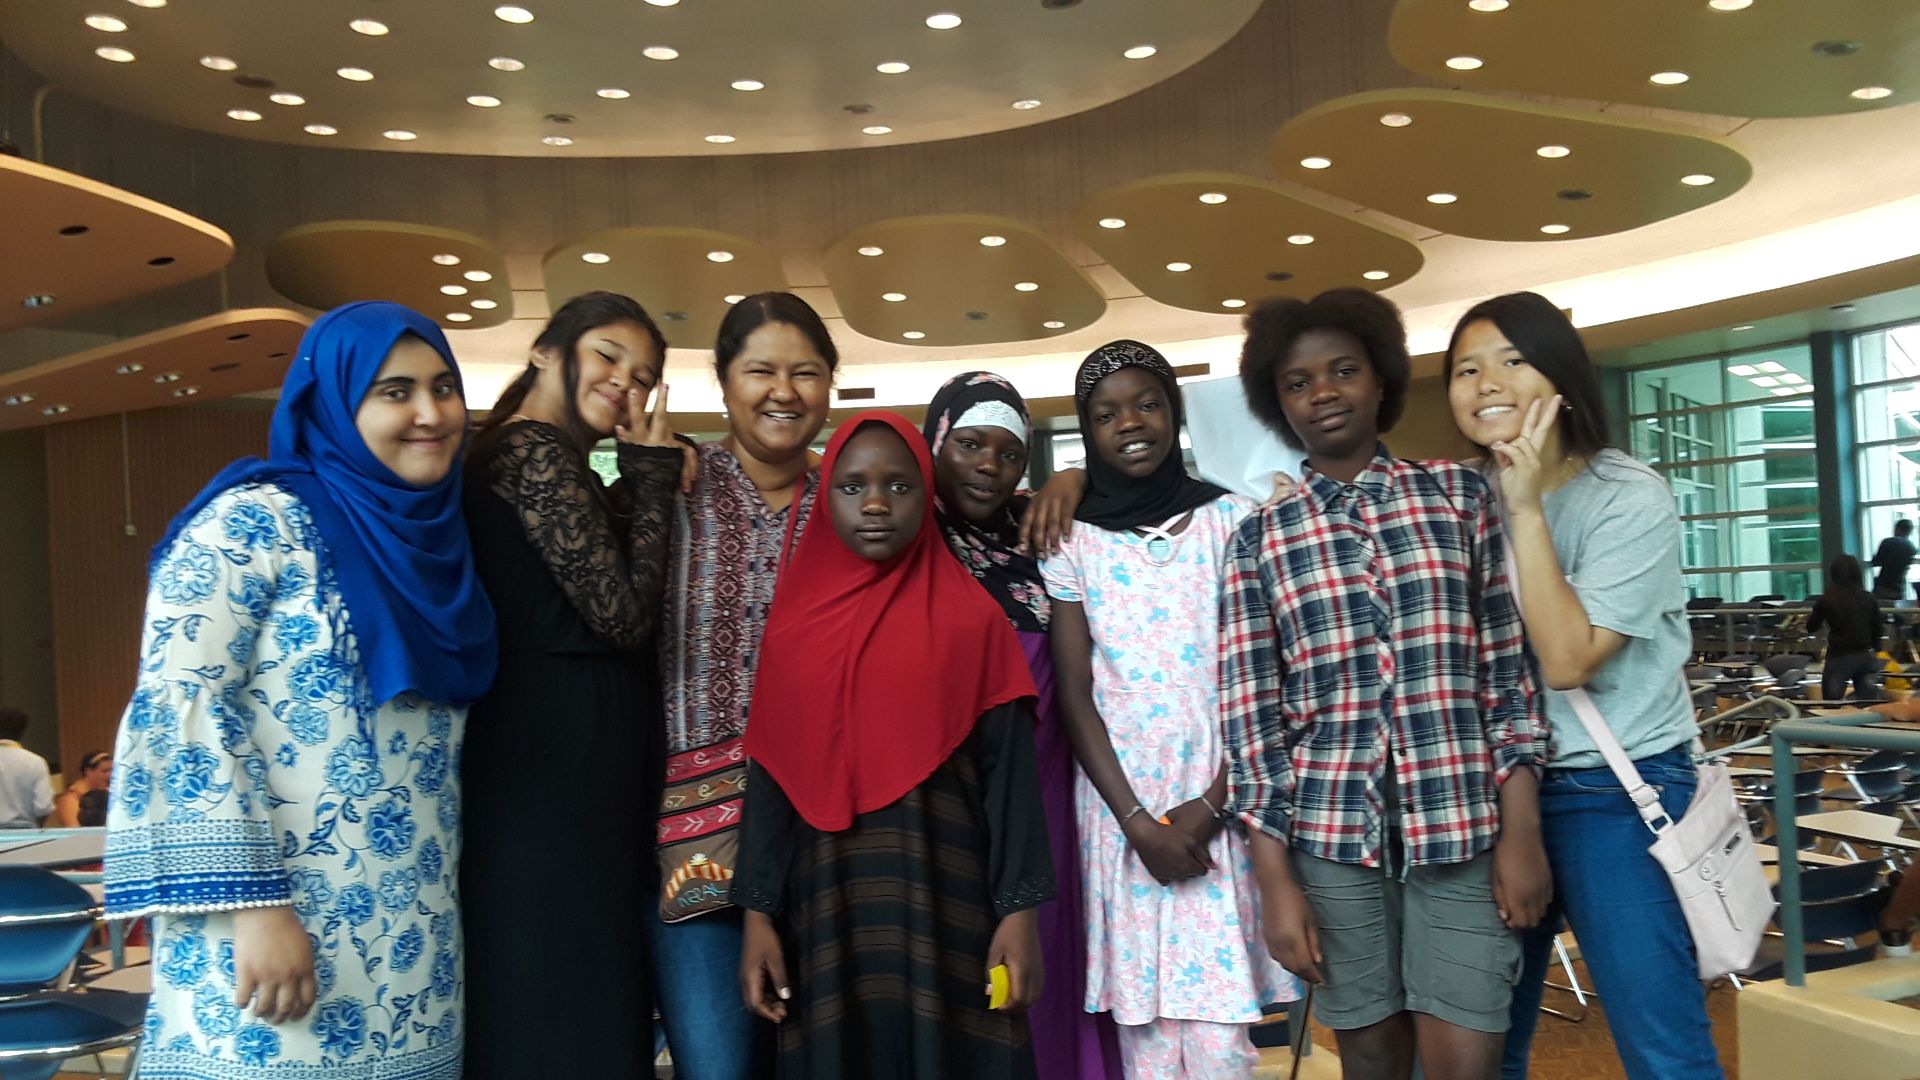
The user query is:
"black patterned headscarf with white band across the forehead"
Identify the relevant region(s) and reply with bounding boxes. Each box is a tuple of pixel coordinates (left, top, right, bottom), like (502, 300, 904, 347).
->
(920, 371, 1052, 634)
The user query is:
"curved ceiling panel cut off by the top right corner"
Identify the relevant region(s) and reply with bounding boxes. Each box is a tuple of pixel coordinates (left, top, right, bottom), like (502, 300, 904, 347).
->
(1388, 0, 1920, 117)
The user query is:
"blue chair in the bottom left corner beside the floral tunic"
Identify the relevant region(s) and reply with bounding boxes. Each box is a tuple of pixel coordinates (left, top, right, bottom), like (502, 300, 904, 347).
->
(0, 867, 146, 1080)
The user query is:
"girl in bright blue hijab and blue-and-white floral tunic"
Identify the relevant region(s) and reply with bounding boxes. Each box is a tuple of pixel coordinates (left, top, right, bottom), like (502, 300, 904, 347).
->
(106, 302, 495, 1080)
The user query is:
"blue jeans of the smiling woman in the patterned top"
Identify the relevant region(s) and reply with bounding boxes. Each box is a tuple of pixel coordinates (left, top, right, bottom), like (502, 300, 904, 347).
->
(643, 909, 772, 1080)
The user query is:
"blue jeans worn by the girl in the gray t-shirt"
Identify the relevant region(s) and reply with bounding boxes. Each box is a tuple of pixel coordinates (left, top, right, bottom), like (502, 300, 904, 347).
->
(1500, 748, 1722, 1080)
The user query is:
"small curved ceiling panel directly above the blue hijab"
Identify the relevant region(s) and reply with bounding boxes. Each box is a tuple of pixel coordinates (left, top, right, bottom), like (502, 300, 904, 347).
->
(267, 221, 513, 331)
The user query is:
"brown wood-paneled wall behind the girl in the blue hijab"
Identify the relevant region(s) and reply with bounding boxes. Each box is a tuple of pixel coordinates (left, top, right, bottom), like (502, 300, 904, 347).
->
(46, 405, 273, 757)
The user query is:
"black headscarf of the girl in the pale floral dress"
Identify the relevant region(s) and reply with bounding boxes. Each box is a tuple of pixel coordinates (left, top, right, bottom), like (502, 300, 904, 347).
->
(1073, 340, 1227, 532)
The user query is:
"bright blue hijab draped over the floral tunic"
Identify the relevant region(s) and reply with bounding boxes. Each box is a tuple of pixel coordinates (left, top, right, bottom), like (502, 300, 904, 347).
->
(152, 300, 497, 705)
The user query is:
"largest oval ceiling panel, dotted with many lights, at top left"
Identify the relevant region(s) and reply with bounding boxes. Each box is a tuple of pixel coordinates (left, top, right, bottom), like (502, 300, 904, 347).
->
(0, 0, 1260, 158)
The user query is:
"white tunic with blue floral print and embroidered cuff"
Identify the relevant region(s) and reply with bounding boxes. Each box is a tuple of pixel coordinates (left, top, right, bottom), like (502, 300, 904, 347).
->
(106, 484, 467, 1080)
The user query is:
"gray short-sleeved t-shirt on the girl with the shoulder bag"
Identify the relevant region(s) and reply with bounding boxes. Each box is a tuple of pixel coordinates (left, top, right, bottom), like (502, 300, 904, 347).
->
(1542, 450, 1699, 769)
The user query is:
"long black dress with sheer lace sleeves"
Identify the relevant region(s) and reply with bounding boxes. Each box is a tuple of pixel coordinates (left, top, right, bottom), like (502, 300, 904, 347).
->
(461, 421, 682, 1080)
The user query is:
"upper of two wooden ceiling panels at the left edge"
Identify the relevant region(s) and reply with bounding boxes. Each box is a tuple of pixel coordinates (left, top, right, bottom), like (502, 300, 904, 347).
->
(0, 156, 234, 331)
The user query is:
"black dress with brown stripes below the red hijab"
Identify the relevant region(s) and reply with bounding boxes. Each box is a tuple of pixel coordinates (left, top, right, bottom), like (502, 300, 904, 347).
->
(733, 703, 1066, 1080)
